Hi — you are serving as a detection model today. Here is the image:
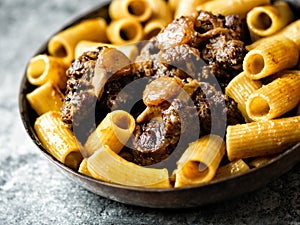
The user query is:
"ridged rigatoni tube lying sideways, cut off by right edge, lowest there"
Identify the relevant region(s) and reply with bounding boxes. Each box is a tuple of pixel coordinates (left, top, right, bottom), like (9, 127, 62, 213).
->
(226, 116, 300, 161)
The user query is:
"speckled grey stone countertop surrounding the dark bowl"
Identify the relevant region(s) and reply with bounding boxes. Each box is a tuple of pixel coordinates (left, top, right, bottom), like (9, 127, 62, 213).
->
(0, 0, 300, 225)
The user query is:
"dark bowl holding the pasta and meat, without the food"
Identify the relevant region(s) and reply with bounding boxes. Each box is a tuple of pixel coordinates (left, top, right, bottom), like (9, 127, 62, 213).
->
(19, 0, 300, 208)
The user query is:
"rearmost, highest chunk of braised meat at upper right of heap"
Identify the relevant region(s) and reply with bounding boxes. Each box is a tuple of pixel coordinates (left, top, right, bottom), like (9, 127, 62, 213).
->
(138, 11, 247, 91)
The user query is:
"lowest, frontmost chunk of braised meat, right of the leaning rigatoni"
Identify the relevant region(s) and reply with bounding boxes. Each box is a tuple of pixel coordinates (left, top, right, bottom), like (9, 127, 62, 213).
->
(127, 99, 199, 166)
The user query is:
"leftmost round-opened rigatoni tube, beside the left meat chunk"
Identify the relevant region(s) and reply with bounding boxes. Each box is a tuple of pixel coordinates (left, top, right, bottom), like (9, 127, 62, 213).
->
(26, 54, 67, 89)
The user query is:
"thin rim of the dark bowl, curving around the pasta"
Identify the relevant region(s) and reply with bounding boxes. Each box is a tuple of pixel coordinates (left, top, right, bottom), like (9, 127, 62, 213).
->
(18, 0, 300, 208)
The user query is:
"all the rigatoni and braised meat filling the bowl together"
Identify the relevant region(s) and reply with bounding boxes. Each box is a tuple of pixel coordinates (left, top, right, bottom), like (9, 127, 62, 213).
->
(26, 0, 300, 188)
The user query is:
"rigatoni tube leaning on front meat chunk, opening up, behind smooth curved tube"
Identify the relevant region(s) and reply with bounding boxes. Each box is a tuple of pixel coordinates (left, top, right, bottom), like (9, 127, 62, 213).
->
(83, 110, 135, 157)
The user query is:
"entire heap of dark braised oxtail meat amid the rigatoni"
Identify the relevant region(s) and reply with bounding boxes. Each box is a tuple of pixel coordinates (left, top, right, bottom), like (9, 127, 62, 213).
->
(62, 11, 247, 166)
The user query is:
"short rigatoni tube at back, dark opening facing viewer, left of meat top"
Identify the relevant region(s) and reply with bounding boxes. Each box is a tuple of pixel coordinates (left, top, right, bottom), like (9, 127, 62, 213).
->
(107, 18, 144, 45)
